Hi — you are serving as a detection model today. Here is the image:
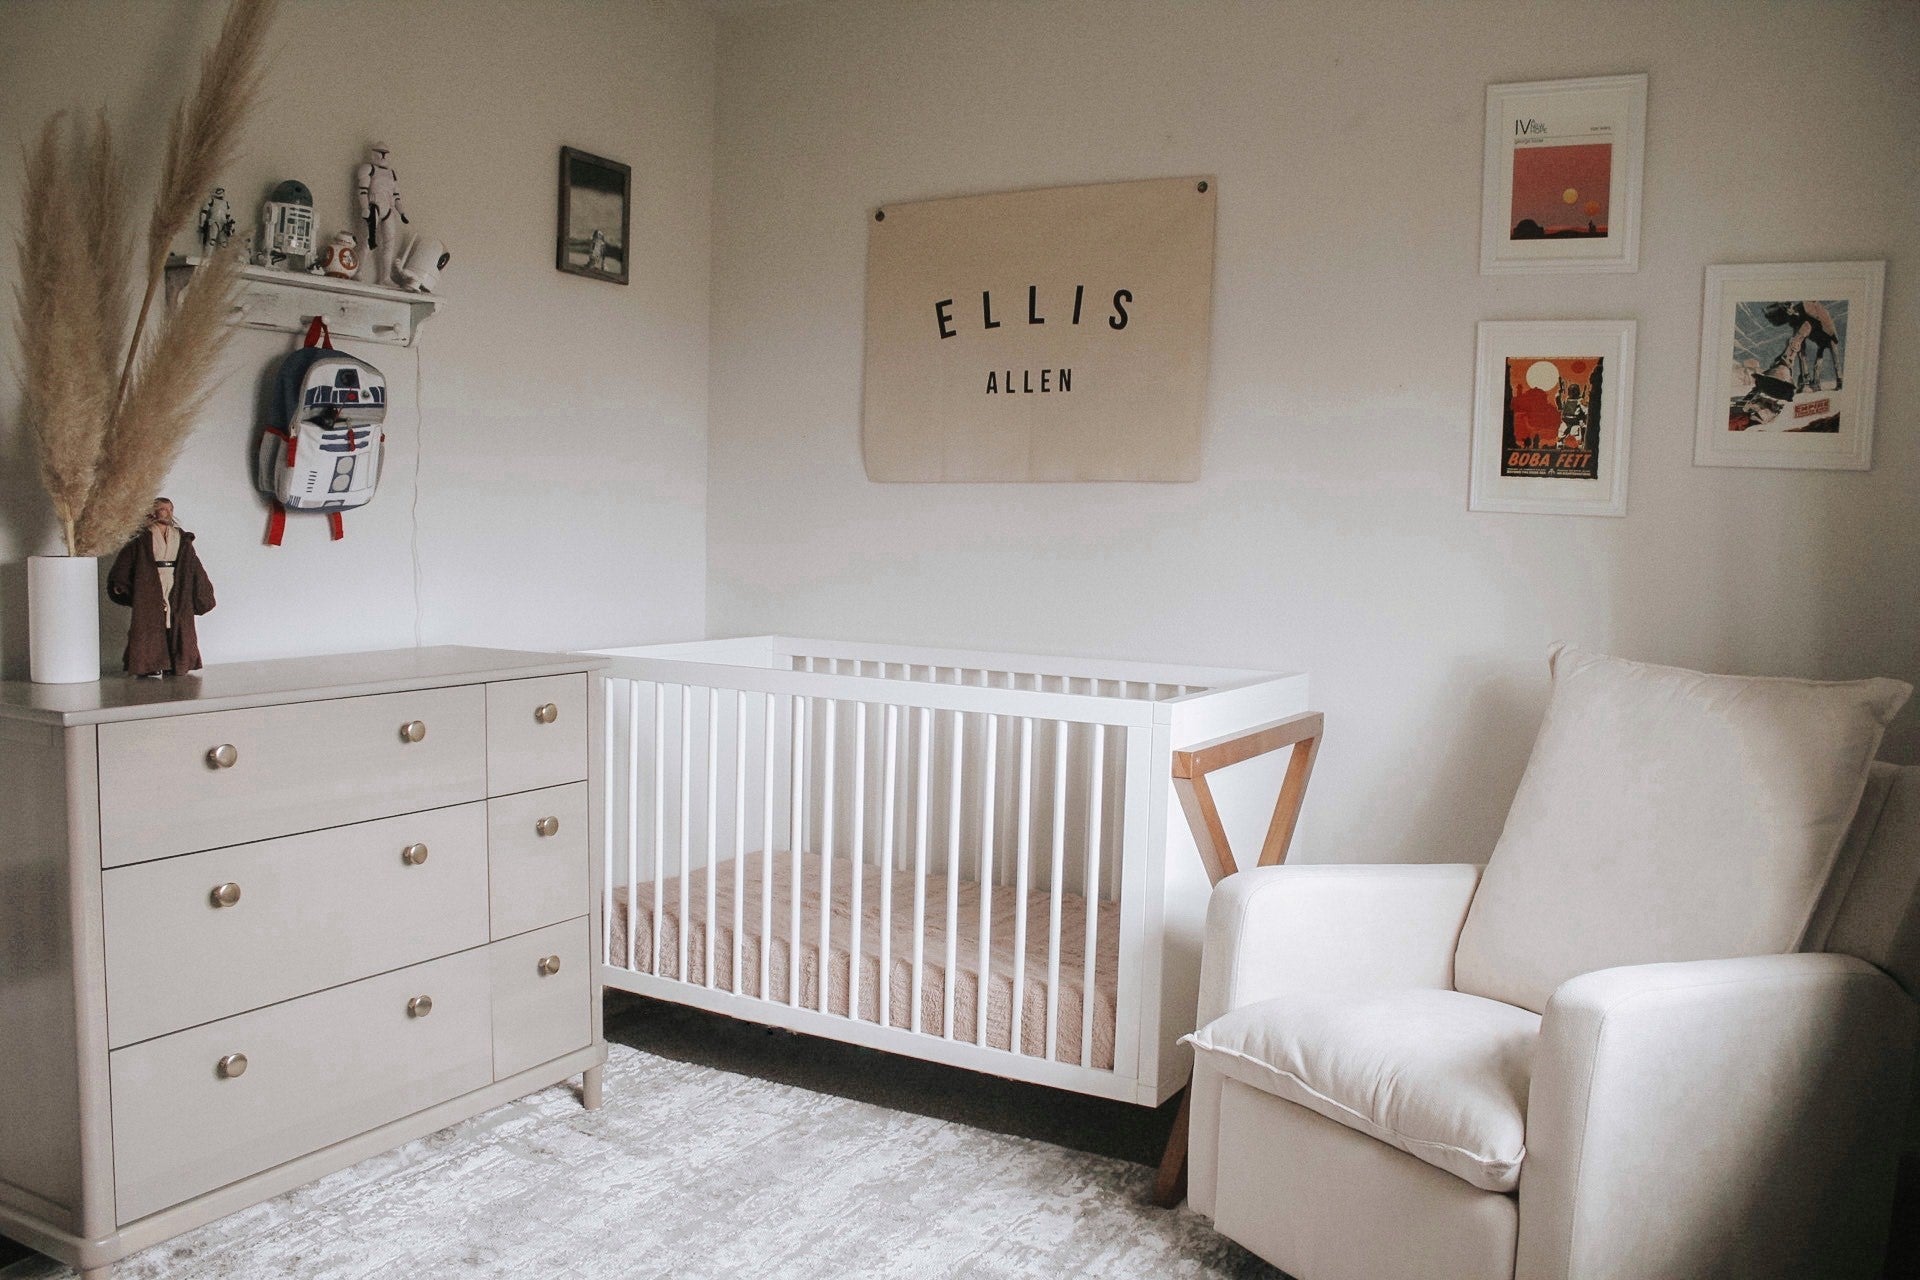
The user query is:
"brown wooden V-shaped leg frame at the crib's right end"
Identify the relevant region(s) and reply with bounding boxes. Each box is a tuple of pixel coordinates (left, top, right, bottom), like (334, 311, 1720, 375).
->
(1154, 712, 1325, 1209)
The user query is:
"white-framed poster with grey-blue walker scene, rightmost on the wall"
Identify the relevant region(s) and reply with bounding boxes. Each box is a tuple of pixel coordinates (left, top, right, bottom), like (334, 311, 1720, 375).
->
(1693, 263, 1887, 470)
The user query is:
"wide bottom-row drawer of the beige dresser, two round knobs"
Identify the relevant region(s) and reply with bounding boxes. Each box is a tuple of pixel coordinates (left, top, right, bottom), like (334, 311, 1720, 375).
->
(109, 948, 493, 1222)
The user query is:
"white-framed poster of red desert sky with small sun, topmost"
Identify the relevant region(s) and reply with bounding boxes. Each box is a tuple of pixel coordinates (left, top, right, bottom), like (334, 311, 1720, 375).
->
(1480, 75, 1647, 274)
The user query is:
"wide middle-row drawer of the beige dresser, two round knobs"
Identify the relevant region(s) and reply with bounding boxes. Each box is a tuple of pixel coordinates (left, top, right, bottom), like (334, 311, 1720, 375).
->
(102, 802, 488, 1048)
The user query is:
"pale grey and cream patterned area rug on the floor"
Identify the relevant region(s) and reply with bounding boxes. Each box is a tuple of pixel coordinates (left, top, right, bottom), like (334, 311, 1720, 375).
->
(11, 1044, 1279, 1280)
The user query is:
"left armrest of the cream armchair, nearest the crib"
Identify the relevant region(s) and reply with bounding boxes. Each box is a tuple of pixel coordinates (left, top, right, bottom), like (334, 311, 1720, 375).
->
(1196, 864, 1480, 1027)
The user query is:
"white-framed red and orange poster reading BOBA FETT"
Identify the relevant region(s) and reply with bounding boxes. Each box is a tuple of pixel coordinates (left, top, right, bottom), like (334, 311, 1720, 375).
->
(1467, 320, 1634, 516)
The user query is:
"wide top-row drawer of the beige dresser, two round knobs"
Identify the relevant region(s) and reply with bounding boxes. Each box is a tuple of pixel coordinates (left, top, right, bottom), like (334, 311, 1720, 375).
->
(100, 685, 486, 867)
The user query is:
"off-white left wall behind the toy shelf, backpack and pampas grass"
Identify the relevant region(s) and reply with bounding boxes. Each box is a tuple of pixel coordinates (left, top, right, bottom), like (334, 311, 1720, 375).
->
(0, 0, 714, 677)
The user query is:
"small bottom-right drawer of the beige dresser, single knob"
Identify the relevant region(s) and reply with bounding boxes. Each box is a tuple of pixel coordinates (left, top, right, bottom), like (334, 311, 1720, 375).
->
(488, 915, 593, 1080)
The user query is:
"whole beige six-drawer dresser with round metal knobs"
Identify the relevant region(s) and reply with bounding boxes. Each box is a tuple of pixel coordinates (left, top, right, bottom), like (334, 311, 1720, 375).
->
(0, 647, 607, 1274)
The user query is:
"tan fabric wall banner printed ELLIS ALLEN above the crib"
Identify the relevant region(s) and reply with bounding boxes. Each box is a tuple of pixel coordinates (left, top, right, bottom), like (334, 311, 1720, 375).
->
(862, 177, 1215, 482)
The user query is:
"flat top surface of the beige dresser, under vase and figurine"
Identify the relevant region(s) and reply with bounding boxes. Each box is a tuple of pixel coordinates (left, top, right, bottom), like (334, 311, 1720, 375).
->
(0, 645, 607, 725)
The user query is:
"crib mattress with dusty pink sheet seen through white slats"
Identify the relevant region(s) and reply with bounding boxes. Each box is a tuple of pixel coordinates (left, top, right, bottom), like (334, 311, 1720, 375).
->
(609, 852, 1119, 1071)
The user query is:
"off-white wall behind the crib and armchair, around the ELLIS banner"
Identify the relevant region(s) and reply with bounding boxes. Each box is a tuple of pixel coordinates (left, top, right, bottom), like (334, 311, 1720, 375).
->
(708, 0, 1920, 860)
